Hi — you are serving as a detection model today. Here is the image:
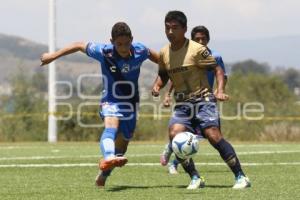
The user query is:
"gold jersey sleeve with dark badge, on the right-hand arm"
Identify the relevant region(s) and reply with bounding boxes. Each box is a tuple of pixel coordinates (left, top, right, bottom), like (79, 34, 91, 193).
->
(195, 46, 217, 70)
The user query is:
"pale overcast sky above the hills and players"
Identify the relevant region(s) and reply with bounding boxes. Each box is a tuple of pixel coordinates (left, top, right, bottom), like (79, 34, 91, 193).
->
(0, 0, 300, 47)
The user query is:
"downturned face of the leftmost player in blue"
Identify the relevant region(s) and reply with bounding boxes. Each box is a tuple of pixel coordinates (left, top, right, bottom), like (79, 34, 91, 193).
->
(111, 36, 132, 58)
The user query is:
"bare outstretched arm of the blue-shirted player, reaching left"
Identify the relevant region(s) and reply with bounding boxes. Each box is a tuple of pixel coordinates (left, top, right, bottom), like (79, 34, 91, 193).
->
(41, 42, 87, 66)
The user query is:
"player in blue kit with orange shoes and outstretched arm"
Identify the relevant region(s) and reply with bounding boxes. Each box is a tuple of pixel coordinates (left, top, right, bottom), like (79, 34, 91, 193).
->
(41, 22, 158, 187)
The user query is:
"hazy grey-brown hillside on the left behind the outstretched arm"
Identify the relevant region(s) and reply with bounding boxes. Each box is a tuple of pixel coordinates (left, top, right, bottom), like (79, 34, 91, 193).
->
(0, 34, 157, 87)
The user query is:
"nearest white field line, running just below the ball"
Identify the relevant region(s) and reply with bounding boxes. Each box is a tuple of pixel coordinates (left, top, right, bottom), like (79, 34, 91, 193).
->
(0, 162, 300, 168)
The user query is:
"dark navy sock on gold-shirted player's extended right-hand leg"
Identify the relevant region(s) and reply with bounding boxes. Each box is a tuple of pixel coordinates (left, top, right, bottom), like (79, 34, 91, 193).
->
(213, 138, 245, 177)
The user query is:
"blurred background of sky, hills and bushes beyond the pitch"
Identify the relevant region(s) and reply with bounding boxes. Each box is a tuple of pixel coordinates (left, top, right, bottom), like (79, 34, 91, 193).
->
(0, 0, 300, 142)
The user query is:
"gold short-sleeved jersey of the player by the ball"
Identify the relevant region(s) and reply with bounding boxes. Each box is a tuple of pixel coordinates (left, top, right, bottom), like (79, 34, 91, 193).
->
(159, 39, 217, 102)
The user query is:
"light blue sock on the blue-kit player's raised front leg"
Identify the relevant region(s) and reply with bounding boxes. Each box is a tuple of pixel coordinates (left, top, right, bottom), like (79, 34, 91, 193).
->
(100, 128, 118, 159)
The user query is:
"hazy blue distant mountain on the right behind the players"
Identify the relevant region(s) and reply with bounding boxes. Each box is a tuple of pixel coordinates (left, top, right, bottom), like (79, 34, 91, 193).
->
(150, 34, 300, 69)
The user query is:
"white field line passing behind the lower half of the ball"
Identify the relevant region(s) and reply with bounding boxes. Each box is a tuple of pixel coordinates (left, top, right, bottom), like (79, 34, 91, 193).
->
(0, 150, 300, 161)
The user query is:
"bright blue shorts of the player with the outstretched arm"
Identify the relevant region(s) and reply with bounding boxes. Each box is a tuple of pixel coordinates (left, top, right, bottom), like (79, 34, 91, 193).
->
(99, 102, 137, 140)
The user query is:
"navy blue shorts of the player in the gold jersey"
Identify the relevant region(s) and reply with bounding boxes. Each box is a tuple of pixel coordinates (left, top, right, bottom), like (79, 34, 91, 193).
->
(169, 95, 220, 135)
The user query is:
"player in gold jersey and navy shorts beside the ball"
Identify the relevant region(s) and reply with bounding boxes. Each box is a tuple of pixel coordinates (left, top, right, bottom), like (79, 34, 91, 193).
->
(152, 11, 250, 189)
